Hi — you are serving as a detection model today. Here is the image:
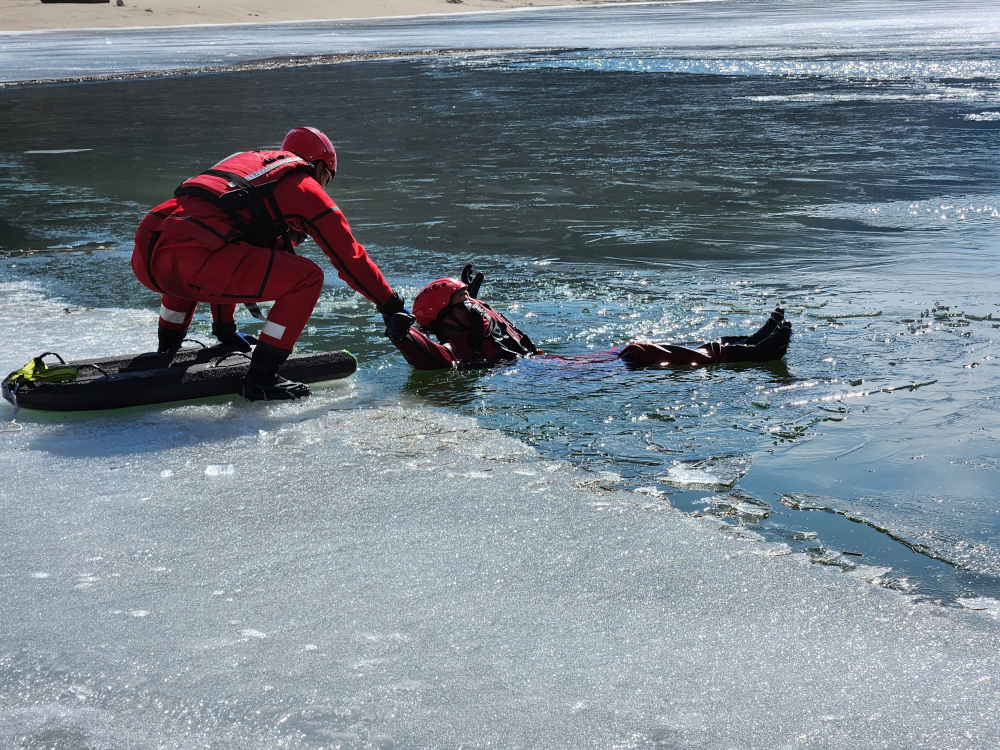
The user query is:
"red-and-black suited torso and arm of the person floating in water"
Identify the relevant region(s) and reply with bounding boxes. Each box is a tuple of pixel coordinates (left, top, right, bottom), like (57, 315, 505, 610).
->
(396, 299, 538, 370)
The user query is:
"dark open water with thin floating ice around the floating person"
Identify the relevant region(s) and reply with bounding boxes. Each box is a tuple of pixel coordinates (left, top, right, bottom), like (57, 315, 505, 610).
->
(0, 23, 1000, 599)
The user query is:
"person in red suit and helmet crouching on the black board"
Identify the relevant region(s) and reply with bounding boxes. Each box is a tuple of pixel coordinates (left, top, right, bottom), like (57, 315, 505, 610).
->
(132, 128, 404, 401)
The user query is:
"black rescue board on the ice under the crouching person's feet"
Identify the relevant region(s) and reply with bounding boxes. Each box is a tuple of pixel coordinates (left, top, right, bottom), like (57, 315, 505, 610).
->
(0, 347, 358, 411)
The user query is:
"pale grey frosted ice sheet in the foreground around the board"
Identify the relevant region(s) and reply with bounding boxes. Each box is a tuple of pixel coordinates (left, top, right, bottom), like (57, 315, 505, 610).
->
(0, 284, 1000, 750)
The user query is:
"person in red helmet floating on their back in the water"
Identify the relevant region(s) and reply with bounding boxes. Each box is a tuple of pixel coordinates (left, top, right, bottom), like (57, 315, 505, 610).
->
(385, 265, 792, 370)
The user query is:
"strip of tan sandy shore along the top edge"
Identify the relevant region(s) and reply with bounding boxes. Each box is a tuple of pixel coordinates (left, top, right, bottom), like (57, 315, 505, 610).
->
(0, 0, 640, 31)
